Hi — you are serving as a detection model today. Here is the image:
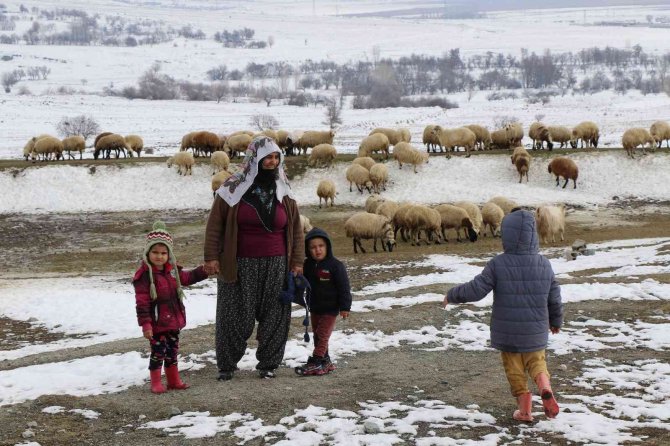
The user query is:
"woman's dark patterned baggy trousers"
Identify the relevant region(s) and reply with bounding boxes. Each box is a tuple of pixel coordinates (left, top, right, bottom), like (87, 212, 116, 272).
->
(216, 256, 291, 372)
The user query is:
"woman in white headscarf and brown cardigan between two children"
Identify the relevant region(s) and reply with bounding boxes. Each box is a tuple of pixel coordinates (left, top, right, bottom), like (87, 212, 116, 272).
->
(205, 137, 305, 381)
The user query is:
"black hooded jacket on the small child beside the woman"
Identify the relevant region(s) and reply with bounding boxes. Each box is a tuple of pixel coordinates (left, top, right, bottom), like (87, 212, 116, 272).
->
(303, 228, 351, 315)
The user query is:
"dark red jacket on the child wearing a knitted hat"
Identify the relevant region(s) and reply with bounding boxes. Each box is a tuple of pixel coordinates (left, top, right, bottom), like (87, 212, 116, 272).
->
(133, 262, 207, 334)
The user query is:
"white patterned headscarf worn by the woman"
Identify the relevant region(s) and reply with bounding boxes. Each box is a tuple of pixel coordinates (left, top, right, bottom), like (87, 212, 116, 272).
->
(216, 136, 293, 206)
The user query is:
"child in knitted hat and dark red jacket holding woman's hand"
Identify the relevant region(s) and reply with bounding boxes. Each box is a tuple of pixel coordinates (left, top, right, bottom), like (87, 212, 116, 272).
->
(133, 221, 207, 393)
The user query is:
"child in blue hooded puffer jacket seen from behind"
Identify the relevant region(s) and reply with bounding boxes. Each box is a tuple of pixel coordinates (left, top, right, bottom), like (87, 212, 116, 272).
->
(443, 210, 563, 422)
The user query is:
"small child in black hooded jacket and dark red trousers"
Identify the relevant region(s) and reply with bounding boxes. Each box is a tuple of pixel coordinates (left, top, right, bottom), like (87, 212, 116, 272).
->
(295, 228, 351, 375)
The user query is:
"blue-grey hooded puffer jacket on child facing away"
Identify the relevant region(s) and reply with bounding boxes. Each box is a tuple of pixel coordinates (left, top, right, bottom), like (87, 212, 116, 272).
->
(447, 210, 563, 352)
